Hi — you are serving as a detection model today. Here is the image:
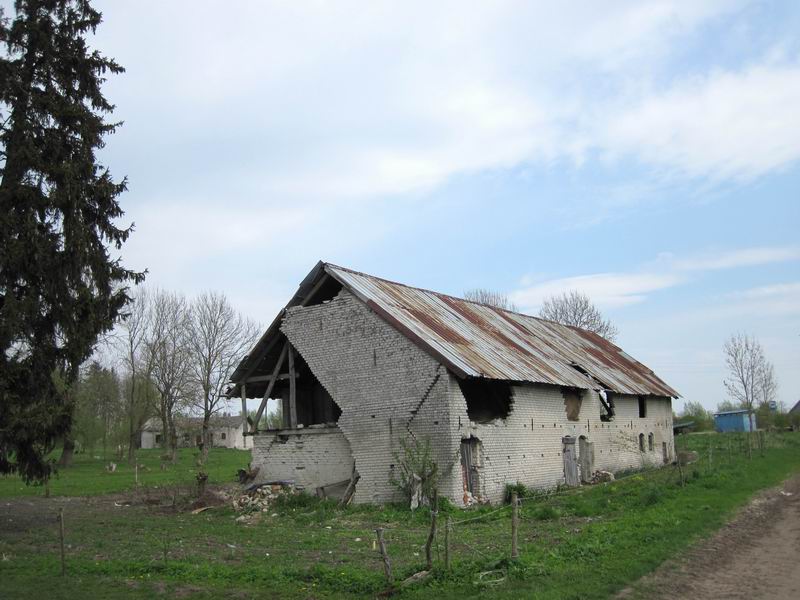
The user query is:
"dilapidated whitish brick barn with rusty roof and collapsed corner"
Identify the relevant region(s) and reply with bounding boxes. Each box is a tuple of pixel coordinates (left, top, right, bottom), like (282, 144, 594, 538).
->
(231, 262, 678, 505)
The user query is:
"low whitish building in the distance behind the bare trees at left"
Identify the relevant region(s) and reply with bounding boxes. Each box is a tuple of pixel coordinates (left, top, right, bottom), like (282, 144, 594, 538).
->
(141, 413, 253, 449)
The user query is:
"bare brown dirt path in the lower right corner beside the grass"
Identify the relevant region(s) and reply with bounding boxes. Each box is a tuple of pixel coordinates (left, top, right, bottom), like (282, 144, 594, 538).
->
(619, 476, 800, 600)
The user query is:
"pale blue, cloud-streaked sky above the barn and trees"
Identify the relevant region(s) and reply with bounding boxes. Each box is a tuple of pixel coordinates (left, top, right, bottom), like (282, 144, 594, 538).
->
(79, 0, 800, 409)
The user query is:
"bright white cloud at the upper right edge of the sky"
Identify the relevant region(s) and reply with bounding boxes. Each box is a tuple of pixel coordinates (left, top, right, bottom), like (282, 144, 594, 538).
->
(598, 62, 800, 180)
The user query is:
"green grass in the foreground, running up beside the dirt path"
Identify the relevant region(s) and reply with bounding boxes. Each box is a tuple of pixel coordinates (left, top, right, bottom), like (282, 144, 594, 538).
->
(0, 434, 800, 599)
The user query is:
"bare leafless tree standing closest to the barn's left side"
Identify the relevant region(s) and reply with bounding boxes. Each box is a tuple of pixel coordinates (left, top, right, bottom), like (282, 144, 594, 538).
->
(188, 292, 259, 462)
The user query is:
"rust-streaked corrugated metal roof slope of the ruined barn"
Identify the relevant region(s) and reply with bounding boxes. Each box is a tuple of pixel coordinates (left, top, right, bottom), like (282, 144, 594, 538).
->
(325, 263, 679, 398)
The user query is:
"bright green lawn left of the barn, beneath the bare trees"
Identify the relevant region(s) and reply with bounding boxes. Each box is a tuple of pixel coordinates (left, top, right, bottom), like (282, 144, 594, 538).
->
(0, 448, 250, 498)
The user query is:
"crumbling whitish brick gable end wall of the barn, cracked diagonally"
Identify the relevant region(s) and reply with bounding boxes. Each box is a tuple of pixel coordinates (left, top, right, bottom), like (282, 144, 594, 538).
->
(281, 290, 459, 502)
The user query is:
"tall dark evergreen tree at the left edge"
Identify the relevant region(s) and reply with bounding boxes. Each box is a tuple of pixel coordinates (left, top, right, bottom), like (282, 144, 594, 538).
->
(0, 0, 144, 481)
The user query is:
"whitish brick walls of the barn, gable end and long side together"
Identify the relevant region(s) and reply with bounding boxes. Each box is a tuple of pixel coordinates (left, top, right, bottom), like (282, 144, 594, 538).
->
(253, 290, 674, 504)
